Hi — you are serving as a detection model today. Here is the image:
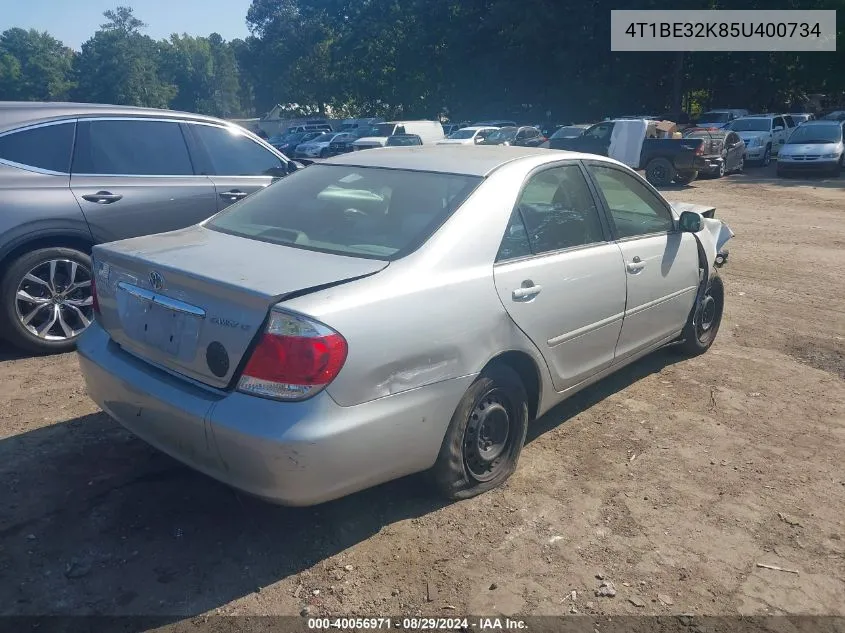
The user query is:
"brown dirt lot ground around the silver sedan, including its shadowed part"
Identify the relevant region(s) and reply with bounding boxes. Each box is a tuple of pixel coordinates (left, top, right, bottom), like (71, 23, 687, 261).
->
(0, 160, 845, 619)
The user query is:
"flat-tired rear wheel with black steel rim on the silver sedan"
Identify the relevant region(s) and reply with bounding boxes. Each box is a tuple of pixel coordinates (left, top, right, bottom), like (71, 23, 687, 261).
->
(431, 364, 528, 500)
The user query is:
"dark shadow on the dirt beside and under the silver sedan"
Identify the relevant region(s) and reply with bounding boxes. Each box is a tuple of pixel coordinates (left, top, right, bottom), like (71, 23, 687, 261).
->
(0, 338, 678, 630)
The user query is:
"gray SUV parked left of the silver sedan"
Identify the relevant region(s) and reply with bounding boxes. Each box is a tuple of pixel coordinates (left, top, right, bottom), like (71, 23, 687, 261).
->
(0, 102, 296, 353)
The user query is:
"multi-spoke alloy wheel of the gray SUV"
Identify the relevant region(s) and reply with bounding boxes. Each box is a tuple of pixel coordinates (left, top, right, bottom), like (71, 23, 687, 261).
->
(15, 259, 94, 341)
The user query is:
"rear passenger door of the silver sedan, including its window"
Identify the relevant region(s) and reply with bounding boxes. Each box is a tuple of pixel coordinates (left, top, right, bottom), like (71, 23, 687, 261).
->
(493, 162, 625, 391)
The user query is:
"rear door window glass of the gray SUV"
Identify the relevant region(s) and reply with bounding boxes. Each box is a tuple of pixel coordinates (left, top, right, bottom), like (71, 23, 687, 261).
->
(73, 119, 194, 176)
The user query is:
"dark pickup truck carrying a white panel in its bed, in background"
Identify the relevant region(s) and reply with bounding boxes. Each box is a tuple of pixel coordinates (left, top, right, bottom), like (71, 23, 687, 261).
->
(557, 119, 706, 187)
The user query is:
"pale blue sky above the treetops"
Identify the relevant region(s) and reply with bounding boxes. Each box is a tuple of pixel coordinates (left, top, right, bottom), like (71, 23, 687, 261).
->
(0, 0, 251, 50)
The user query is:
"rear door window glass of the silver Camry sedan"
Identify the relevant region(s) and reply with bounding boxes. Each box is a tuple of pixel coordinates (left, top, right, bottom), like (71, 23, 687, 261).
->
(517, 165, 604, 254)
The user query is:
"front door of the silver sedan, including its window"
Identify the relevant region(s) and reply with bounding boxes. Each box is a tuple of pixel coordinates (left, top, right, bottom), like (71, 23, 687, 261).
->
(588, 163, 699, 360)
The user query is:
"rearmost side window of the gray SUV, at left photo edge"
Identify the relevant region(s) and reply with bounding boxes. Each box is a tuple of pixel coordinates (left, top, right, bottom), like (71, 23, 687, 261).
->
(0, 122, 76, 174)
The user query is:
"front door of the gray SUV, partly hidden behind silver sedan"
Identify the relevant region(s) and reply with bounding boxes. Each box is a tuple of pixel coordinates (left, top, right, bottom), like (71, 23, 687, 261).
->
(186, 123, 290, 210)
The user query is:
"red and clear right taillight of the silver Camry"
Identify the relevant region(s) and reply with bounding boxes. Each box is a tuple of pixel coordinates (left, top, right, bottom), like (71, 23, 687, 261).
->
(238, 311, 348, 400)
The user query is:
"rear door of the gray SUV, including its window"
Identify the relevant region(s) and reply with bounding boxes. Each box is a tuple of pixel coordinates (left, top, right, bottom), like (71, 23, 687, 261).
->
(70, 117, 217, 242)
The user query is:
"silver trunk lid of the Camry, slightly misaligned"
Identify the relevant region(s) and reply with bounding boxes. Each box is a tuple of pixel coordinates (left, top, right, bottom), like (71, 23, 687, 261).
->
(94, 226, 388, 388)
